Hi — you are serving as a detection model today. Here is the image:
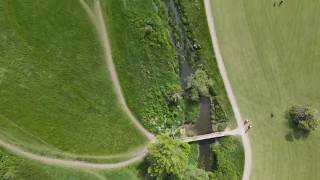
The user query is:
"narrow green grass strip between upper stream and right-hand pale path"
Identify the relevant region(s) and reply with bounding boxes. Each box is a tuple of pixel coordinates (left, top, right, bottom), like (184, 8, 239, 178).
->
(181, 0, 235, 126)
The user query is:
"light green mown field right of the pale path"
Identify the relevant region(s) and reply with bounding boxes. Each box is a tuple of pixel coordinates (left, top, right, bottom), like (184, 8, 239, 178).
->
(213, 0, 320, 180)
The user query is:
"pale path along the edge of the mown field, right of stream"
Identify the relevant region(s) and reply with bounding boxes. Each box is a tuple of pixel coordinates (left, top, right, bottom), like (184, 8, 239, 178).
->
(204, 0, 252, 180)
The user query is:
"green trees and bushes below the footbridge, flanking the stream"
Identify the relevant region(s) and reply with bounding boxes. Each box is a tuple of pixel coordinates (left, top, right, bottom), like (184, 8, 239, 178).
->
(147, 135, 244, 180)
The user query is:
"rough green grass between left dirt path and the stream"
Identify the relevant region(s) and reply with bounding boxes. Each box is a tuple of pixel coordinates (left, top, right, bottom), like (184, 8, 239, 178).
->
(104, 0, 184, 132)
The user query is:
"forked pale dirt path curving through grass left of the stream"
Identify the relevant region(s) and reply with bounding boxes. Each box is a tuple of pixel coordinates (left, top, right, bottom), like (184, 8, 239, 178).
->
(0, 0, 152, 170)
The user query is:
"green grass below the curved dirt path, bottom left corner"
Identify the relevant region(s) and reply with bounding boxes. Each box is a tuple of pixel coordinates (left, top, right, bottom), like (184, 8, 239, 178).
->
(0, 150, 142, 180)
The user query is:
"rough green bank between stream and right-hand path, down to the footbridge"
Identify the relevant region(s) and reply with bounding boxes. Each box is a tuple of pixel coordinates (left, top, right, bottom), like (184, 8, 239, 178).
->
(175, 0, 235, 130)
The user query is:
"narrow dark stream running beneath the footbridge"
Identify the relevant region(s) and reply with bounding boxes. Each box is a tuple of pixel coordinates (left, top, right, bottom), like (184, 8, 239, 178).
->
(164, 0, 214, 170)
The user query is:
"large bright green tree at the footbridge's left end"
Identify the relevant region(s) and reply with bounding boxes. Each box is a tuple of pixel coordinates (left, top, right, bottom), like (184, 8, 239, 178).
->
(148, 135, 190, 179)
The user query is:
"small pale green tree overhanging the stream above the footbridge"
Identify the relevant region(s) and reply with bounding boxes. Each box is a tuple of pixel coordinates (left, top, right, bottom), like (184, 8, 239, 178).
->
(188, 69, 213, 100)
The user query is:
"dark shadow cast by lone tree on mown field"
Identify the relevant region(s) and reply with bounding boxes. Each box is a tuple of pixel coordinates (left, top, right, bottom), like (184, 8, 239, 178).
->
(285, 111, 310, 142)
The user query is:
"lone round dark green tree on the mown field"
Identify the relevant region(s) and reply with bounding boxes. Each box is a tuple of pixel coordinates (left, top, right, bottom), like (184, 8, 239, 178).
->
(289, 105, 319, 132)
